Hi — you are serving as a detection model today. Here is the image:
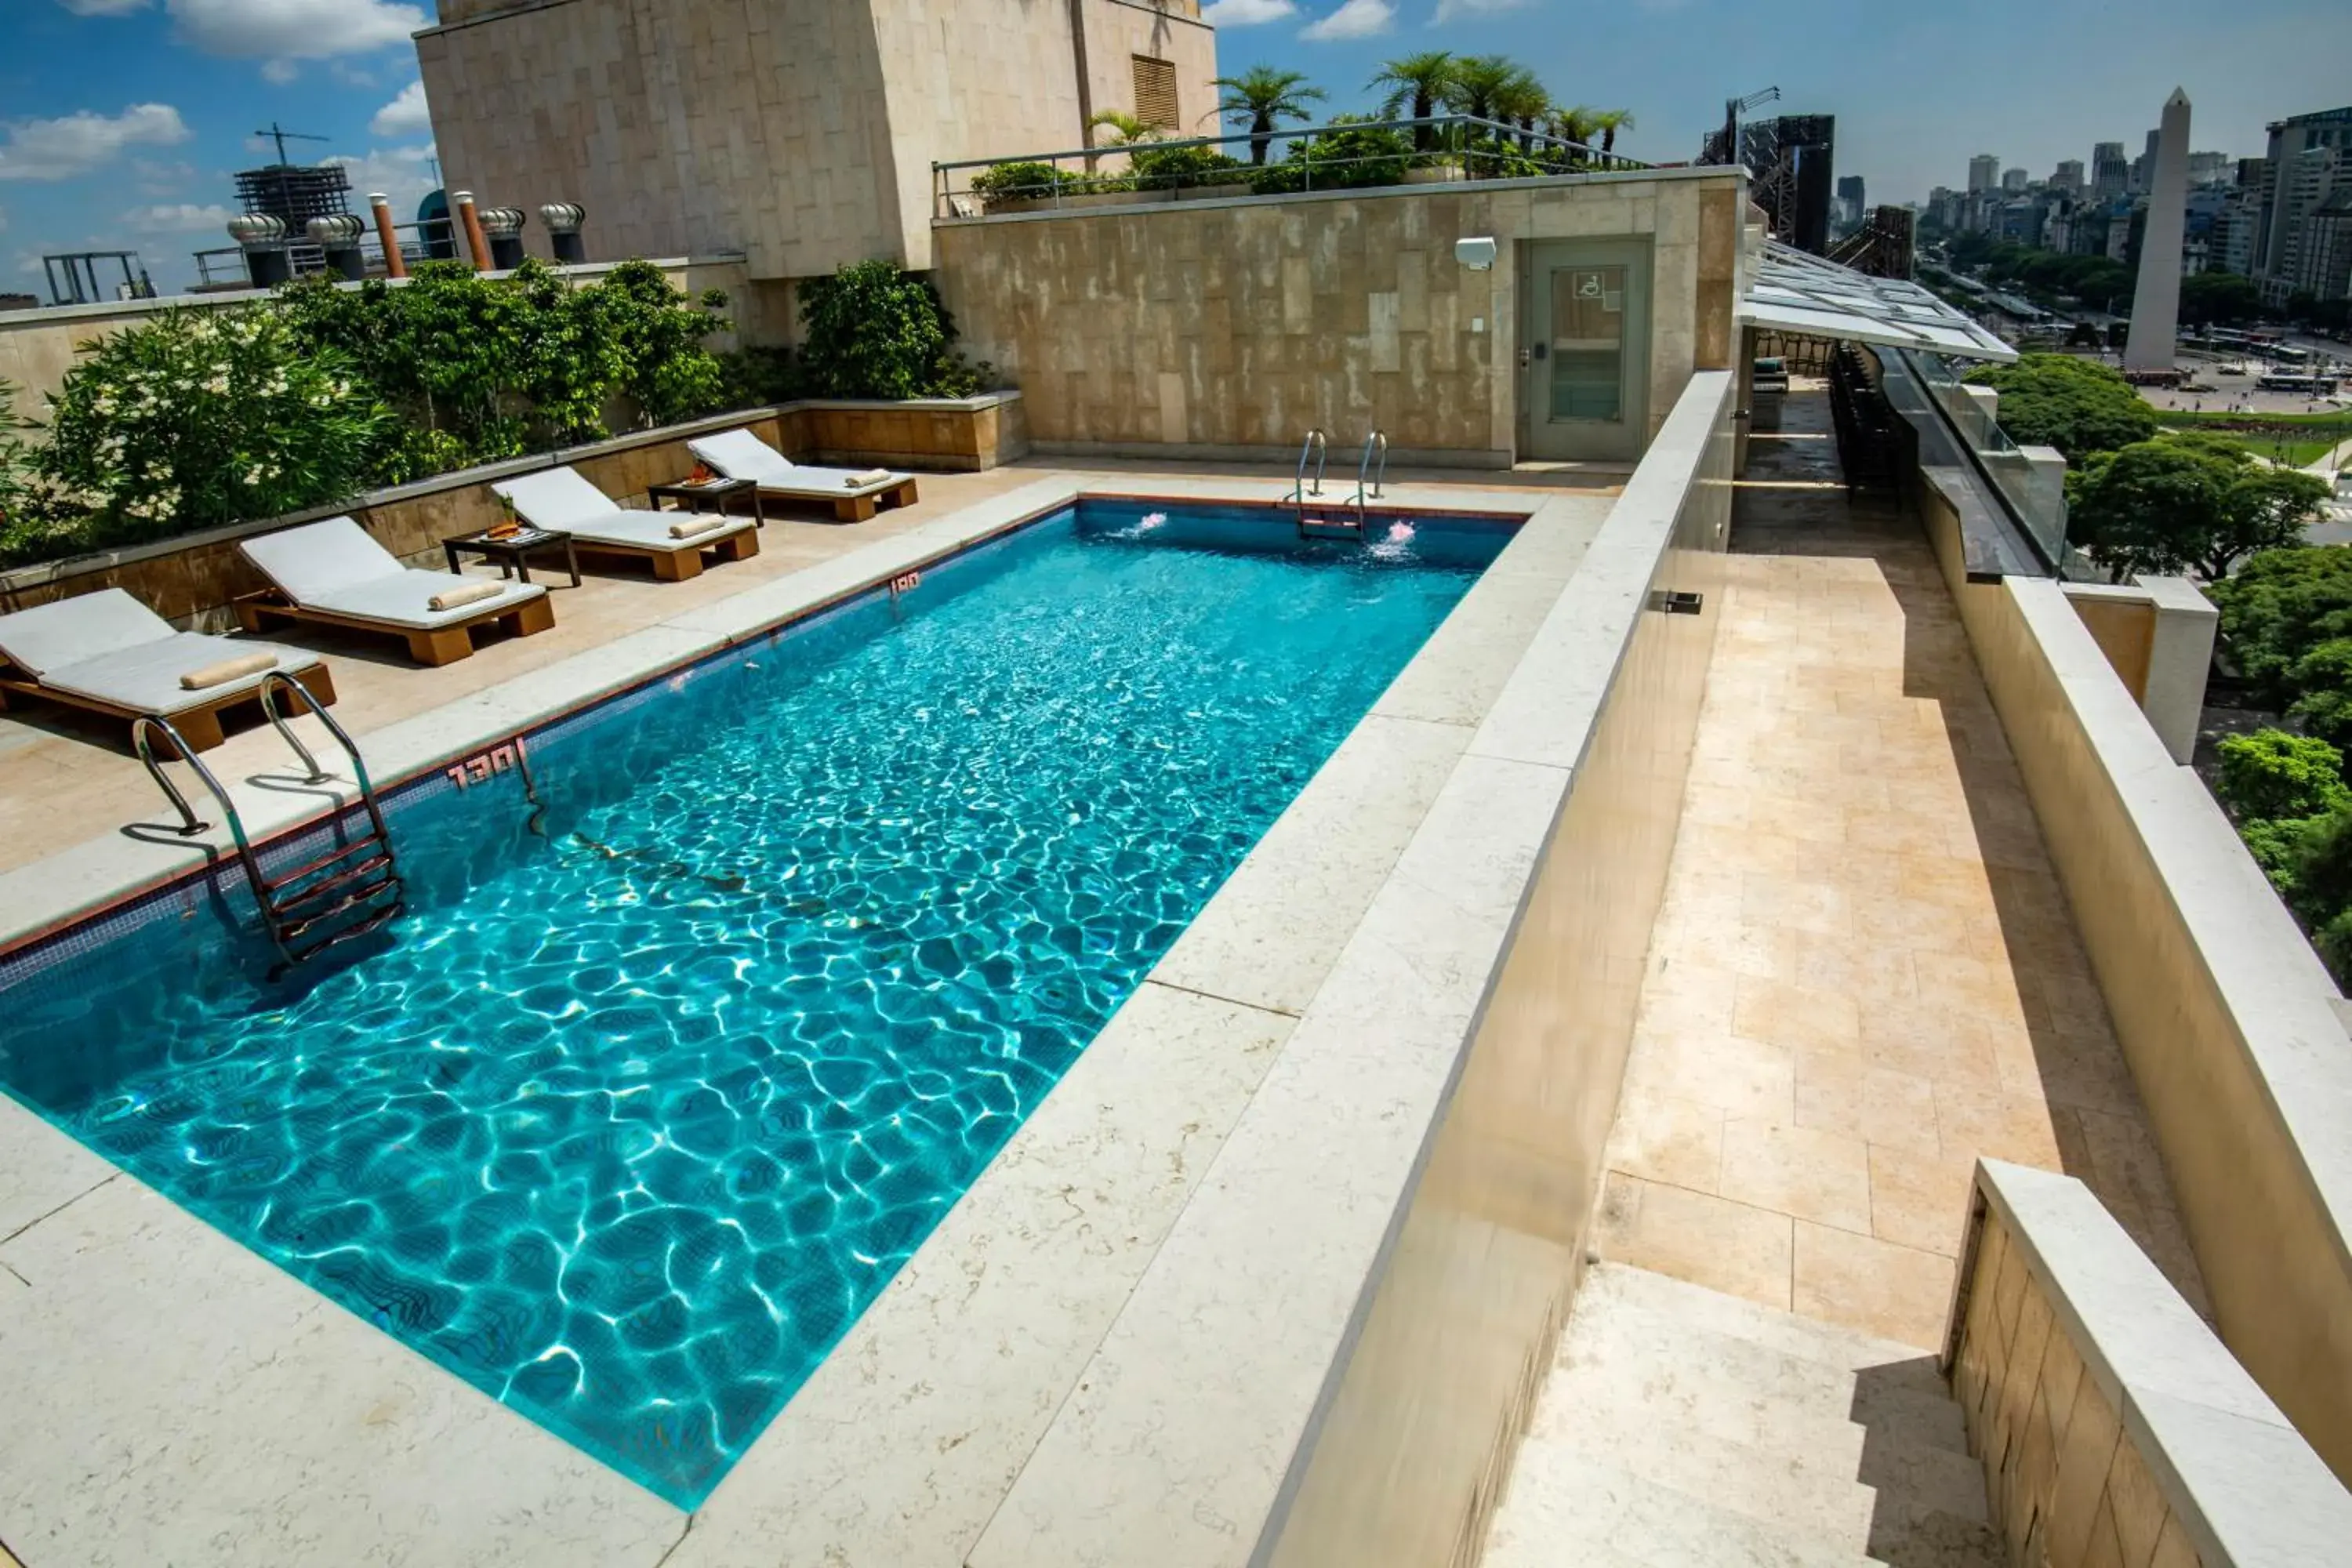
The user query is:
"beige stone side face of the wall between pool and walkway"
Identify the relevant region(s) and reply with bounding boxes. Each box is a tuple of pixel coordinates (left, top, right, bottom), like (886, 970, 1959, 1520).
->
(1256, 379, 1733, 1568)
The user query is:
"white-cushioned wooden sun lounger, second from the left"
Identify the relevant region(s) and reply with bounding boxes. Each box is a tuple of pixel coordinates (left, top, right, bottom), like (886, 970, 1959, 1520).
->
(238, 517, 555, 666)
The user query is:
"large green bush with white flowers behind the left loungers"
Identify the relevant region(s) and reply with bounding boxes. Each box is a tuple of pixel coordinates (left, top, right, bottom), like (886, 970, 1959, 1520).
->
(38, 306, 393, 546)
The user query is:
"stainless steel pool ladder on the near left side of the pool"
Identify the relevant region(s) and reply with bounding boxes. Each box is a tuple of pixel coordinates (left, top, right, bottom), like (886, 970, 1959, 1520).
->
(132, 670, 405, 978)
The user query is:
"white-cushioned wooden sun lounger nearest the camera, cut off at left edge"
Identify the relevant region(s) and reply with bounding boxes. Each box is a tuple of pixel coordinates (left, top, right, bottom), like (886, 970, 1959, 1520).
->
(0, 588, 334, 753)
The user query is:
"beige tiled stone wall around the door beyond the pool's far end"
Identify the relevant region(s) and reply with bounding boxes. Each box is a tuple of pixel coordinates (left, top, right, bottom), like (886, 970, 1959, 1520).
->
(936, 172, 1740, 461)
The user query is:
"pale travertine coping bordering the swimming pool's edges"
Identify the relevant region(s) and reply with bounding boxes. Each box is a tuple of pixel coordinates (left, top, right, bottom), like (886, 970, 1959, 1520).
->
(0, 453, 1628, 1568)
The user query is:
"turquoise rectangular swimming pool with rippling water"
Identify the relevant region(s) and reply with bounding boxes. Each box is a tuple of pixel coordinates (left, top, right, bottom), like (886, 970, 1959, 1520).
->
(0, 501, 1508, 1507)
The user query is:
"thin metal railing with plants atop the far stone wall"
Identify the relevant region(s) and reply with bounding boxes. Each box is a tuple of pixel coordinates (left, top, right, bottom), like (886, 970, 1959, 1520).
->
(931, 115, 1656, 219)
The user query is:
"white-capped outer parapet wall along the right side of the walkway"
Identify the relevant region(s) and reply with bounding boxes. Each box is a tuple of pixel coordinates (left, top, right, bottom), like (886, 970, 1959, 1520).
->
(1924, 489, 2352, 1476)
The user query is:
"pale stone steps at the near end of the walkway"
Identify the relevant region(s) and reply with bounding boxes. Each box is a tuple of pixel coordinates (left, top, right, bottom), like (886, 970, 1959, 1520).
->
(1486, 1262, 1999, 1568)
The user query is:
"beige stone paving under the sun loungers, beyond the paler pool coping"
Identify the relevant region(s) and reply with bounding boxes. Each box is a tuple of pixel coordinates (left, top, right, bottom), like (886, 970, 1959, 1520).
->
(0, 461, 1618, 872)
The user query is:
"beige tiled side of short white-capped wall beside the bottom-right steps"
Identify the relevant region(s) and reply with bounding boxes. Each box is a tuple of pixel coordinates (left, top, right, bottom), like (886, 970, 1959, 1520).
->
(1952, 1215, 2199, 1568)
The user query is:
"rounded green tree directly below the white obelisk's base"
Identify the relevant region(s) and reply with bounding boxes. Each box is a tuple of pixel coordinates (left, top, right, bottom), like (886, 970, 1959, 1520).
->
(2070, 434, 2328, 583)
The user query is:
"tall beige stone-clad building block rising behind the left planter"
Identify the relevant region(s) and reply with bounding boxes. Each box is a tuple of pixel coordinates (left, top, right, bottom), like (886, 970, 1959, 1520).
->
(416, 0, 1216, 280)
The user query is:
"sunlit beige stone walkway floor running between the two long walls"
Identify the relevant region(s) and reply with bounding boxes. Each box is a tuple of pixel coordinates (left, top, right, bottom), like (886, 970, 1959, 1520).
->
(1602, 397, 2204, 1345)
